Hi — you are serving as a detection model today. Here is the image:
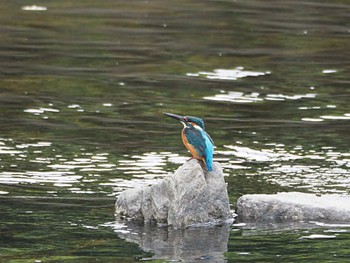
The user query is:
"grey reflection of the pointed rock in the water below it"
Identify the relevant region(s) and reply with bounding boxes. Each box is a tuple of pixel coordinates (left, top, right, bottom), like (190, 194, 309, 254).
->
(111, 222, 230, 262)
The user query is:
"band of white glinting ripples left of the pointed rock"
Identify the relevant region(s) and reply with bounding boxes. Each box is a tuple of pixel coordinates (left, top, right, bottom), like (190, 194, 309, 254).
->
(0, 138, 188, 196)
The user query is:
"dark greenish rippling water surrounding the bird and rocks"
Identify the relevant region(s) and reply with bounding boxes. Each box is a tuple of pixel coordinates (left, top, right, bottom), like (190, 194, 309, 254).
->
(0, 0, 350, 262)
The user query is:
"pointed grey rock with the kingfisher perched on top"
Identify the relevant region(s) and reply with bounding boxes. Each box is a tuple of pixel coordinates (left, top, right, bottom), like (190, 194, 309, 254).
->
(116, 160, 232, 227)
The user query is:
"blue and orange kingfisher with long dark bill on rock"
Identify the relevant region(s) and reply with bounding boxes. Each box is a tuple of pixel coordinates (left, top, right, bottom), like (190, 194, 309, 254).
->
(164, 112, 214, 172)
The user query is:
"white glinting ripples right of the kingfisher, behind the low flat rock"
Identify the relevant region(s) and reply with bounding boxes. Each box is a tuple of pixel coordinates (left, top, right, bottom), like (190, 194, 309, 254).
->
(217, 144, 350, 193)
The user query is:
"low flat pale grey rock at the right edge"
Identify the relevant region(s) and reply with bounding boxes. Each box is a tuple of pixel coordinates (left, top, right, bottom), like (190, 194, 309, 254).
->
(237, 192, 350, 223)
